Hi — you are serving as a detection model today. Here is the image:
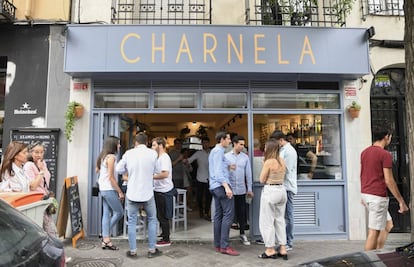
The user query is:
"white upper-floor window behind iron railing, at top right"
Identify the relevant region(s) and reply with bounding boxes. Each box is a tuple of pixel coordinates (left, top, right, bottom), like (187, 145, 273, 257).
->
(363, 0, 404, 16)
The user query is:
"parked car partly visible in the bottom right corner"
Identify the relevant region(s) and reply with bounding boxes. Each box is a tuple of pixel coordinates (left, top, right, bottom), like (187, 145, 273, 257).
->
(299, 243, 414, 267)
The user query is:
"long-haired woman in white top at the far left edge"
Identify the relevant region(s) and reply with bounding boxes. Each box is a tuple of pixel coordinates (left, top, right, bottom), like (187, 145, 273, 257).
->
(0, 141, 30, 193)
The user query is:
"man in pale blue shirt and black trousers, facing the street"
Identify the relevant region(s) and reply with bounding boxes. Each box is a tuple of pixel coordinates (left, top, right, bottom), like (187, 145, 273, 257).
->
(225, 135, 253, 246)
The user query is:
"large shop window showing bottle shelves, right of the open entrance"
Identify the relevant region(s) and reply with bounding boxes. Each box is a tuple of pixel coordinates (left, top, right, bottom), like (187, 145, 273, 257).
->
(253, 114, 342, 182)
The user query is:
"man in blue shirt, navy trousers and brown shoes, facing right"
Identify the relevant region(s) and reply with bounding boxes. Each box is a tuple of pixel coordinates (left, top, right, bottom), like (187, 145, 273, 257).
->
(208, 132, 240, 256)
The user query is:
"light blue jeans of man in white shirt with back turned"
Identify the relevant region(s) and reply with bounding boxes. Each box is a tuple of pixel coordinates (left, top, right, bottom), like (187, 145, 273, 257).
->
(127, 197, 157, 252)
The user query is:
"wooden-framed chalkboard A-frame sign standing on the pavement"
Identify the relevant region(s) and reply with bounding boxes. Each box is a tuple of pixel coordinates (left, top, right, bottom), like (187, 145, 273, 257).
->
(56, 176, 85, 247)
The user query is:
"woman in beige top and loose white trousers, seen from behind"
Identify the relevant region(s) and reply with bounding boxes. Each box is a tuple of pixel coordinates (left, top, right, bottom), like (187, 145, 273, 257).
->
(259, 139, 288, 260)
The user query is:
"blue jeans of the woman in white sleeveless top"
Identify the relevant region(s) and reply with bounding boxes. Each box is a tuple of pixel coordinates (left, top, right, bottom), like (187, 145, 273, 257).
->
(101, 190, 124, 237)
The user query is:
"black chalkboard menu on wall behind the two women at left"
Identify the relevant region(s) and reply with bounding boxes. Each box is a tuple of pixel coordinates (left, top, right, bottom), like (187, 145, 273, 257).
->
(11, 128, 60, 193)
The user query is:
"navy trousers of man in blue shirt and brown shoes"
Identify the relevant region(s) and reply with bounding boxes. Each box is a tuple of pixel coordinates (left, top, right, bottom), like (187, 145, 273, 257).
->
(211, 186, 234, 248)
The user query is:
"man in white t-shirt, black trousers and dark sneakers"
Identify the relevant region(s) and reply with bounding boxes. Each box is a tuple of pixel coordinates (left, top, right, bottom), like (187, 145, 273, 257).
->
(152, 137, 175, 247)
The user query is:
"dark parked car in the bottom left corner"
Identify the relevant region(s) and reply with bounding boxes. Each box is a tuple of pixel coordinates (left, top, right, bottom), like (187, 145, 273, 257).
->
(0, 199, 65, 267)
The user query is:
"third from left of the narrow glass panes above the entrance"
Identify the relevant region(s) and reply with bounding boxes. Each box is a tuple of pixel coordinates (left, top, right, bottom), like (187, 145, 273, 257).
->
(203, 93, 247, 109)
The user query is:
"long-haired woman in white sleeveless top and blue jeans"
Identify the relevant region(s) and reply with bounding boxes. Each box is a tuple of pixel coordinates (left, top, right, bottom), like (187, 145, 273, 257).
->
(96, 136, 124, 250)
